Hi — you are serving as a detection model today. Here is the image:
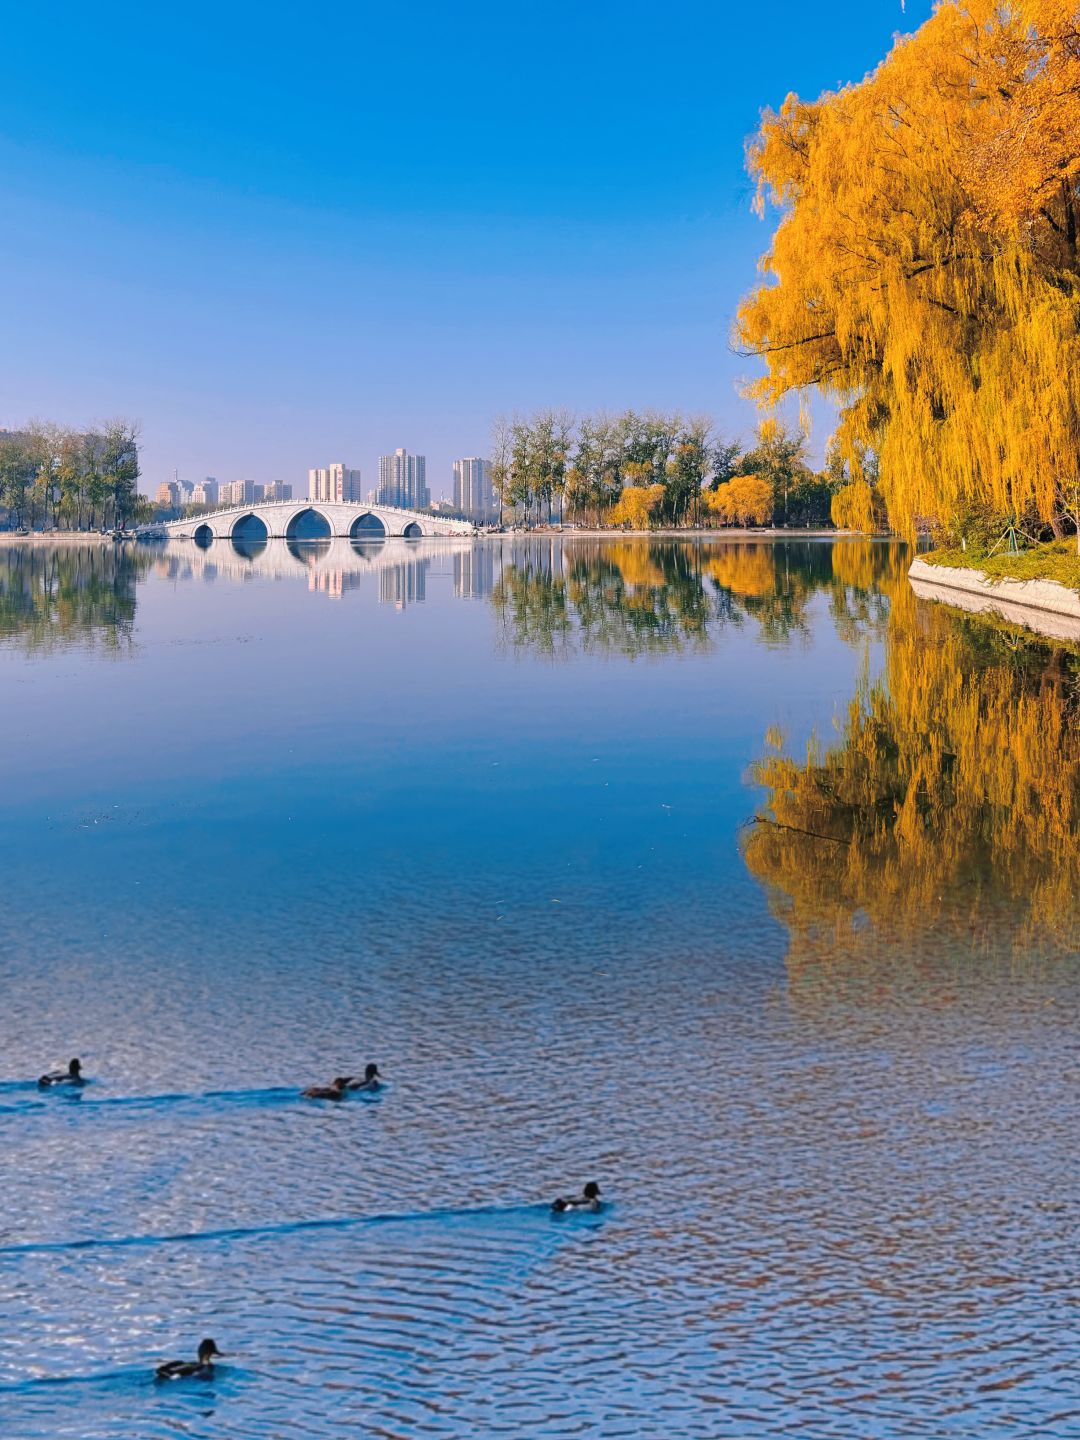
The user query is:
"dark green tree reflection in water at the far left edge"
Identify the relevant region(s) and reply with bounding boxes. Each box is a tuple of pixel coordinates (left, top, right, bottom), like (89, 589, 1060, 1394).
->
(0, 544, 151, 652)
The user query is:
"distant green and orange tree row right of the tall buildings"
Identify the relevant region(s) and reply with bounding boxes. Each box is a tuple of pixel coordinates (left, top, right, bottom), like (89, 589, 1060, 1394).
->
(491, 410, 884, 530)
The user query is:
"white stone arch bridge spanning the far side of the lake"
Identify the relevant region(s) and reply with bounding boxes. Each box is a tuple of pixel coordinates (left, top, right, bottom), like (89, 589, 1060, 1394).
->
(164, 500, 477, 544)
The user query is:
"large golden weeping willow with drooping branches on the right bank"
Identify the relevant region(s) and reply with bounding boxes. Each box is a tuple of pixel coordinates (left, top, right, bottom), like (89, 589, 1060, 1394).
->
(737, 0, 1080, 534)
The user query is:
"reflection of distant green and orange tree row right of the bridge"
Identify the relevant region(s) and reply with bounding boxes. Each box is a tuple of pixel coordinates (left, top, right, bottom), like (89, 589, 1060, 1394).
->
(492, 540, 904, 657)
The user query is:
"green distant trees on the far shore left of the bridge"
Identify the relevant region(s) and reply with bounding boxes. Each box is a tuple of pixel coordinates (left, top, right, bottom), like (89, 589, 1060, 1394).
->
(0, 420, 148, 530)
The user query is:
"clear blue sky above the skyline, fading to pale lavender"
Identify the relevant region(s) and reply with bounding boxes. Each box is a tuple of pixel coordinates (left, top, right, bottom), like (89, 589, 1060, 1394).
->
(0, 0, 930, 495)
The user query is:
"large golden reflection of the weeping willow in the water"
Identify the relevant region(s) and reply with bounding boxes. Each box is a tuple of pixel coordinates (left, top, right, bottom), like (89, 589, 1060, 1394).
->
(744, 547, 1080, 971)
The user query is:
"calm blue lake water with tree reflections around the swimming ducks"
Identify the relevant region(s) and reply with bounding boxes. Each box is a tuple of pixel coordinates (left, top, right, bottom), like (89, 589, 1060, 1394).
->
(0, 540, 1080, 1440)
